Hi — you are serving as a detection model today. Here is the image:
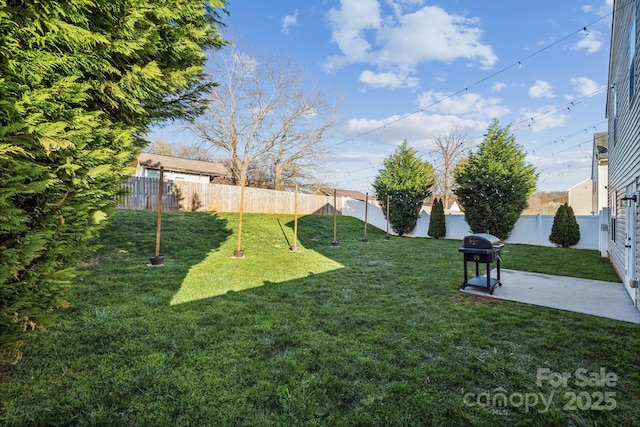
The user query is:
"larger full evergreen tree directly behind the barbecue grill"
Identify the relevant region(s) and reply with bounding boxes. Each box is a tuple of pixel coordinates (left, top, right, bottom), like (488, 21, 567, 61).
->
(453, 119, 538, 239)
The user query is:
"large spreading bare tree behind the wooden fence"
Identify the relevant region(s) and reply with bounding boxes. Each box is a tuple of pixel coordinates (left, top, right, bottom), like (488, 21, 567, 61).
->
(190, 48, 338, 190)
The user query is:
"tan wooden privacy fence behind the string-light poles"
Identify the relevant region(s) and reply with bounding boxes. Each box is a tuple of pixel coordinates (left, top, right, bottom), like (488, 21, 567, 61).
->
(118, 177, 342, 215)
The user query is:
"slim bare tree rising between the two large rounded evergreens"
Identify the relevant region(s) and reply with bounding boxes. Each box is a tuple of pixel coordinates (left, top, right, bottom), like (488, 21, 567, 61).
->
(433, 125, 473, 209)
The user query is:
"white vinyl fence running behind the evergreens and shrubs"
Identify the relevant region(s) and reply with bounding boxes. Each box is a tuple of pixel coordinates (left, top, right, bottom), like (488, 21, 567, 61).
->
(342, 199, 608, 256)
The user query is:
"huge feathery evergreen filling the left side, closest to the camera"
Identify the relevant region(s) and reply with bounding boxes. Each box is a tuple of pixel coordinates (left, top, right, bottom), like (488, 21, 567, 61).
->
(0, 0, 225, 359)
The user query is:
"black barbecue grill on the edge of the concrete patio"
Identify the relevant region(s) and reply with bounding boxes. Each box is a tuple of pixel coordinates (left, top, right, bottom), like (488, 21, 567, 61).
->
(458, 233, 504, 294)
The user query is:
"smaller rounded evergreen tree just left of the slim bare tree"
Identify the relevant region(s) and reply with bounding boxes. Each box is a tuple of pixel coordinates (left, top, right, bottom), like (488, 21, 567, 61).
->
(373, 140, 434, 236)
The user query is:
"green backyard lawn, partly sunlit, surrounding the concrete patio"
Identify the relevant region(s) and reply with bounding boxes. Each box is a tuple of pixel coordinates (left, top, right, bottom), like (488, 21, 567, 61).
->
(0, 211, 640, 426)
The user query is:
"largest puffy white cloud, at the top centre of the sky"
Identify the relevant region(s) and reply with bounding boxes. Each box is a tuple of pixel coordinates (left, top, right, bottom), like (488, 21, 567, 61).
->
(325, 0, 498, 80)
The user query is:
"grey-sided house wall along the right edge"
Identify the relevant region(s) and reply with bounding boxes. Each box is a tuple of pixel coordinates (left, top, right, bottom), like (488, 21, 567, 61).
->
(606, 0, 640, 306)
